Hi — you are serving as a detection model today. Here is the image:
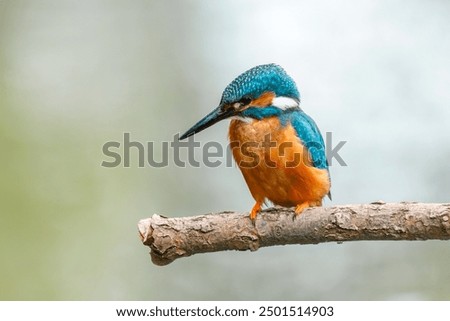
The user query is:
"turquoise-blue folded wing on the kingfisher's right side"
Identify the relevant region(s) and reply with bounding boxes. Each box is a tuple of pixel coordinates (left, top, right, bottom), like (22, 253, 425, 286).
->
(284, 109, 328, 170)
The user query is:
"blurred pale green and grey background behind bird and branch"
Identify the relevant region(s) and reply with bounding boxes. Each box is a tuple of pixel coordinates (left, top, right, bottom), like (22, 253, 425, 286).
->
(0, 0, 450, 300)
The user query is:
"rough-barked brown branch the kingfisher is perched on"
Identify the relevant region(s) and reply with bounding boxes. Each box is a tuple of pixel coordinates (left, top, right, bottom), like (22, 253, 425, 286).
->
(138, 201, 450, 265)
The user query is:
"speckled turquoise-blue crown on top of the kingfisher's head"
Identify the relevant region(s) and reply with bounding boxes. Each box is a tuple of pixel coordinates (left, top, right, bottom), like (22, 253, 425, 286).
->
(220, 64, 300, 104)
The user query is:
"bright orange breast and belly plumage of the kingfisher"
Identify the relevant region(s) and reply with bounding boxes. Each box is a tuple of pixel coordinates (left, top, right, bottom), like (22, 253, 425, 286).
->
(229, 117, 330, 207)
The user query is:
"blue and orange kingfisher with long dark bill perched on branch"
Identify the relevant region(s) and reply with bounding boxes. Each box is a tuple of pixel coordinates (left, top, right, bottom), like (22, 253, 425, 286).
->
(180, 64, 331, 225)
